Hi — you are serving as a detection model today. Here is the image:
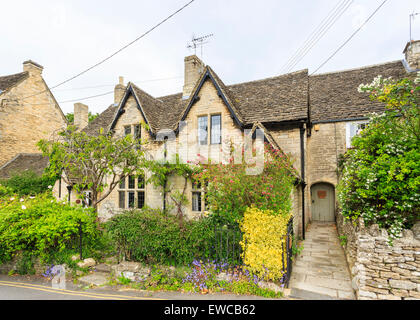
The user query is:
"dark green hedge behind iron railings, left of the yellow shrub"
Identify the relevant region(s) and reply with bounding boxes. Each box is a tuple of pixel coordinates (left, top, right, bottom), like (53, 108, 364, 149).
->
(105, 208, 214, 265)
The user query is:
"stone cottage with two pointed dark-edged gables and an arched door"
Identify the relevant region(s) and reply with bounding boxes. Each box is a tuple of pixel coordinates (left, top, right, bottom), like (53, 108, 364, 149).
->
(54, 41, 419, 236)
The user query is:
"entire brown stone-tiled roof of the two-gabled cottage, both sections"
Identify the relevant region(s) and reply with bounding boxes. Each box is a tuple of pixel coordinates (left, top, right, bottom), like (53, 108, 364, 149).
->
(84, 61, 407, 133)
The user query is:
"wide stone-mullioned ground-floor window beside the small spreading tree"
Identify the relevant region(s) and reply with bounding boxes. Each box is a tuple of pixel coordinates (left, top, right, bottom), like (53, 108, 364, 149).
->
(118, 173, 145, 209)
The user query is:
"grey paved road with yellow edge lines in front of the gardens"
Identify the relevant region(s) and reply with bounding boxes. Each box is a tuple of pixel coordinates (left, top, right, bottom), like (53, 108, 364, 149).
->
(0, 275, 276, 300)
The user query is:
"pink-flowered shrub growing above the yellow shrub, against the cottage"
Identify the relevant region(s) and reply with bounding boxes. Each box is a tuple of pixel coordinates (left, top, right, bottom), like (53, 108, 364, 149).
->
(194, 143, 297, 227)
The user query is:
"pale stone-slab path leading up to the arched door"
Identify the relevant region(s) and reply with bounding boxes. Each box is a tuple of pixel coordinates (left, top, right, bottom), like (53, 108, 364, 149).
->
(289, 222, 355, 300)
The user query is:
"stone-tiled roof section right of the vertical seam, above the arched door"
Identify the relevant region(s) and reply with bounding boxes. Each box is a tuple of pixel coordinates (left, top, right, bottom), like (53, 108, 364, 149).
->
(309, 61, 407, 122)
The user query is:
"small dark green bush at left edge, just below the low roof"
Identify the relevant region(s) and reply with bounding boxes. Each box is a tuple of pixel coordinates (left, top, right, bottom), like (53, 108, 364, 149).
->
(0, 171, 57, 196)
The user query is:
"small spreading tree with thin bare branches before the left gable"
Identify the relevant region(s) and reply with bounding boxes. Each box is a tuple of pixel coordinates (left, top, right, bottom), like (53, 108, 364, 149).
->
(38, 126, 144, 210)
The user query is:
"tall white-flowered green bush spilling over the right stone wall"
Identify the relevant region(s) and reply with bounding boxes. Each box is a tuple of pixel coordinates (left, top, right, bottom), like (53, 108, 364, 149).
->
(338, 73, 420, 240)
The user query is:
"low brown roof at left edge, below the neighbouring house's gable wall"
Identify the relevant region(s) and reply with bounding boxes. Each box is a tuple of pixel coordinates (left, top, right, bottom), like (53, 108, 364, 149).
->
(0, 153, 49, 179)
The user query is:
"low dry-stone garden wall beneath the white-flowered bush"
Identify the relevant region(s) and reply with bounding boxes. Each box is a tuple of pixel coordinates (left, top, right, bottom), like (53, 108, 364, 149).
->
(337, 213, 420, 300)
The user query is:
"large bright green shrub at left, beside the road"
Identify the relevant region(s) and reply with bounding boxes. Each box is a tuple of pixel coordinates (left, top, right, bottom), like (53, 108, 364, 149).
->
(0, 193, 99, 262)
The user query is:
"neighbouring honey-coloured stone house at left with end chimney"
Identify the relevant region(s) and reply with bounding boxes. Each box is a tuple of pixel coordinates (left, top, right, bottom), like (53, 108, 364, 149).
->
(0, 60, 67, 178)
